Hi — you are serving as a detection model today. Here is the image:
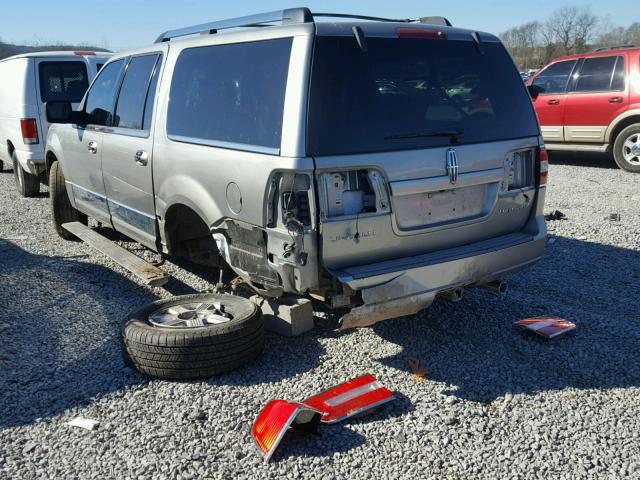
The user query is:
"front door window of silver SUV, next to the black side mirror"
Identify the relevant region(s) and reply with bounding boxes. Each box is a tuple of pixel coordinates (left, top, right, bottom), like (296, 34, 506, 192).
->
(84, 59, 124, 126)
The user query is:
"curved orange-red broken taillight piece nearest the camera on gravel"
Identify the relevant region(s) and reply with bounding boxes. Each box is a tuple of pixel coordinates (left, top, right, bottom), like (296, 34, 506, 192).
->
(251, 400, 321, 462)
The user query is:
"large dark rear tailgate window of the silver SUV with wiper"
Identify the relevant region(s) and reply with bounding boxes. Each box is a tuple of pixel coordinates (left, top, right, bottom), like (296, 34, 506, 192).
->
(307, 37, 539, 155)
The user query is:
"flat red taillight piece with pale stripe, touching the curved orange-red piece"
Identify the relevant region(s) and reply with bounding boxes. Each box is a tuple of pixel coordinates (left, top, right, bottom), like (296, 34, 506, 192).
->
(303, 374, 395, 423)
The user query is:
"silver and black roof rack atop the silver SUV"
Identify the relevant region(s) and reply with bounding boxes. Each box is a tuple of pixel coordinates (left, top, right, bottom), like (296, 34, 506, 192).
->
(155, 7, 451, 43)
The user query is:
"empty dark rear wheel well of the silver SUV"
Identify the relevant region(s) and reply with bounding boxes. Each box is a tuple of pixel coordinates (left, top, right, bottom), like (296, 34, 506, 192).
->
(164, 204, 223, 266)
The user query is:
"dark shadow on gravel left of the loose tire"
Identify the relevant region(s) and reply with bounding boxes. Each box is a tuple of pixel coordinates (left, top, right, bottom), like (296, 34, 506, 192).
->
(0, 239, 152, 428)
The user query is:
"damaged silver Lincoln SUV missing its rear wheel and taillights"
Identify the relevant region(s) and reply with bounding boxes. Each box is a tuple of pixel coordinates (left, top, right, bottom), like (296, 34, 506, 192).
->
(46, 8, 547, 326)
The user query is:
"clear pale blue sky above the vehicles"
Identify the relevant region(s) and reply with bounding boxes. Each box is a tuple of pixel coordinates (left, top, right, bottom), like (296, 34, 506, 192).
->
(0, 0, 640, 50)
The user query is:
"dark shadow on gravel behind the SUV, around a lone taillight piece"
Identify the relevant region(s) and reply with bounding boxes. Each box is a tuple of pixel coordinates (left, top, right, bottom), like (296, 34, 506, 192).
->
(374, 237, 640, 402)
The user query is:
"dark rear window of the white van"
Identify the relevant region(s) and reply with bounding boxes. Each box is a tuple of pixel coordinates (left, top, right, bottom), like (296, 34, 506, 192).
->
(38, 62, 89, 103)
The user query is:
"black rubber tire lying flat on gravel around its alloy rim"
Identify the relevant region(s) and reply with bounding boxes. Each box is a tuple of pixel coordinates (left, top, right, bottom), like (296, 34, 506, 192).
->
(122, 294, 264, 380)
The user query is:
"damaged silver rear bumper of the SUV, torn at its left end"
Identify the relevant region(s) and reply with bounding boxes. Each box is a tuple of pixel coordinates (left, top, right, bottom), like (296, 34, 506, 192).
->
(333, 216, 546, 329)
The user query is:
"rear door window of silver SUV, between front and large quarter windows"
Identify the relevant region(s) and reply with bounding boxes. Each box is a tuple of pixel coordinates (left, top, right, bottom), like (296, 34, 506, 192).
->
(113, 55, 158, 130)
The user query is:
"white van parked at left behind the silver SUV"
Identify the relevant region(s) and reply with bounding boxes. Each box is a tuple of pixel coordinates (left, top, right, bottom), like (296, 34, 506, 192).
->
(0, 51, 111, 197)
